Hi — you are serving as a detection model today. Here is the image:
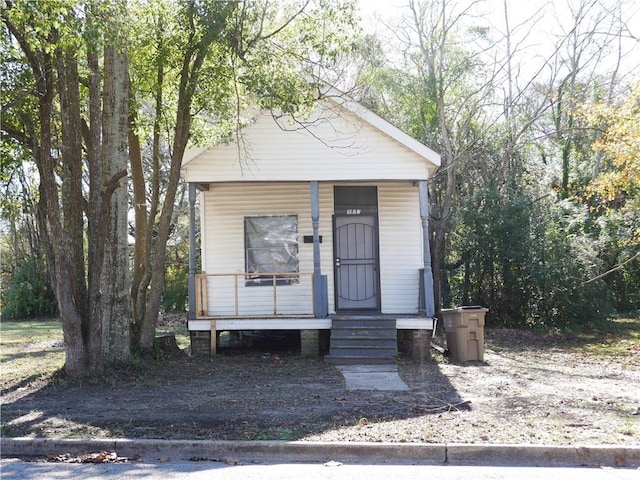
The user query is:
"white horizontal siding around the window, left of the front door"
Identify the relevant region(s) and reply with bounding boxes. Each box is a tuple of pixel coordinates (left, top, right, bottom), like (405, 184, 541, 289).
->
(202, 183, 333, 315)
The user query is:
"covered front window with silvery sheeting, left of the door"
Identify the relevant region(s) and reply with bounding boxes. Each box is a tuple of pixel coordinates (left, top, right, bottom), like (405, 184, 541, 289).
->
(244, 215, 298, 285)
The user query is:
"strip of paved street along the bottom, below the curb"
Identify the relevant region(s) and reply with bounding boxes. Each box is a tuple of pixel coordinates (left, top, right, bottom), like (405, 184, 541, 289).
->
(0, 459, 640, 480)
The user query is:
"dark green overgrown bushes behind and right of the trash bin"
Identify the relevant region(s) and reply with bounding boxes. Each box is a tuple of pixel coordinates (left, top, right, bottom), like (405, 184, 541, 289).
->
(443, 186, 628, 329)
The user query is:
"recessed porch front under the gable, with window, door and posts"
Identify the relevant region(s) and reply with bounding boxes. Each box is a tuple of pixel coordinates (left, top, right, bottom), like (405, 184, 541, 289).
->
(189, 181, 434, 320)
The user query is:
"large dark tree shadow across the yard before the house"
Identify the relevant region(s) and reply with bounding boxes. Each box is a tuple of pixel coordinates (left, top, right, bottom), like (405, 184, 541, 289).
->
(2, 336, 462, 440)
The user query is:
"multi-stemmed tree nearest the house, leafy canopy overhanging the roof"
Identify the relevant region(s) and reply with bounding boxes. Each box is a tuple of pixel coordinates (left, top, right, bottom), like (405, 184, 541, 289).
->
(129, 0, 362, 351)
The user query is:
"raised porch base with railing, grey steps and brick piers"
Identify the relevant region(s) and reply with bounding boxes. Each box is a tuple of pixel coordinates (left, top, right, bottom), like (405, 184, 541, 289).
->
(188, 262, 435, 364)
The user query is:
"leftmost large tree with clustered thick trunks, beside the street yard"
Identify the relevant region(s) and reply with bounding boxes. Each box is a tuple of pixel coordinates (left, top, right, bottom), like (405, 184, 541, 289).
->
(2, 1, 129, 376)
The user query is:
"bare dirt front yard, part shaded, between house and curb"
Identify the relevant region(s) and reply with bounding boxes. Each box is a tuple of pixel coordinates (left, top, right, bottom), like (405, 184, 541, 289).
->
(2, 320, 640, 445)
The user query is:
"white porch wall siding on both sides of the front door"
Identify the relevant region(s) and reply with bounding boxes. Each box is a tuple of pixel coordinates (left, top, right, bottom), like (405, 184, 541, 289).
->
(201, 182, 422, 315)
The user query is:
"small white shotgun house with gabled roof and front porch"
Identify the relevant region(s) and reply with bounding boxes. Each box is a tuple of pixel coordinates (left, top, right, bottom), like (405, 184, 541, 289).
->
(182, 97, 440, 357)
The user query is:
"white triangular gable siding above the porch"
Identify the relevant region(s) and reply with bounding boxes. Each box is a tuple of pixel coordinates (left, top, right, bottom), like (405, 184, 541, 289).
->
(183, 106, 439, 183)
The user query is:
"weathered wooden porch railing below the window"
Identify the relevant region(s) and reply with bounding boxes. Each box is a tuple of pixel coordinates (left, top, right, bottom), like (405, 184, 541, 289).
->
(195, 272, 315, 318)
